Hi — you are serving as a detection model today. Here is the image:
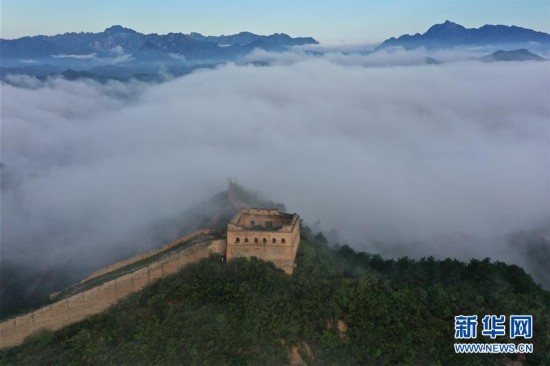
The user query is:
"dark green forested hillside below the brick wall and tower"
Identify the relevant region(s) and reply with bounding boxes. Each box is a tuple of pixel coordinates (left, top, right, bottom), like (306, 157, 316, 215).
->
(0, 227, 550, 365)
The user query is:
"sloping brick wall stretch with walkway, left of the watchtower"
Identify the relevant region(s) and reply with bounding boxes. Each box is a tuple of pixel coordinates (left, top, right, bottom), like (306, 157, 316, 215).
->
(0, 230, 226, 349)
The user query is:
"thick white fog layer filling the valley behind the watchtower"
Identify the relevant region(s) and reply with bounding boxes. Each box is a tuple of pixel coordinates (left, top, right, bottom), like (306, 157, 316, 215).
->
(1, 56, 550, 278)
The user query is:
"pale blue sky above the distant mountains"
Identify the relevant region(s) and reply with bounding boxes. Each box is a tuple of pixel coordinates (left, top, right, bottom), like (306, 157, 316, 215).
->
(0, 0, 550, 43)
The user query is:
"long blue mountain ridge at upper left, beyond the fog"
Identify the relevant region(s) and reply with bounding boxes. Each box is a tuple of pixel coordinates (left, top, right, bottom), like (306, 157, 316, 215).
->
(0, 25, 318, 59)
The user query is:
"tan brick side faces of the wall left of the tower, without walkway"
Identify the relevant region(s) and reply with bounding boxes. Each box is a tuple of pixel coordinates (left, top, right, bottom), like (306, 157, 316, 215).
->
(0, 234, 226, 348)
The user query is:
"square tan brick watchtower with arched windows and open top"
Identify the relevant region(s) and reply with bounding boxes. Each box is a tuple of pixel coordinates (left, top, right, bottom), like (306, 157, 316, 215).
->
(226, 208, 300, 274)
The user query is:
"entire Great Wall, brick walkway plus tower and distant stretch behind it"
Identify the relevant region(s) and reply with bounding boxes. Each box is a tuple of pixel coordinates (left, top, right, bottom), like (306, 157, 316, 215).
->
(0, 182, 300, 349)
